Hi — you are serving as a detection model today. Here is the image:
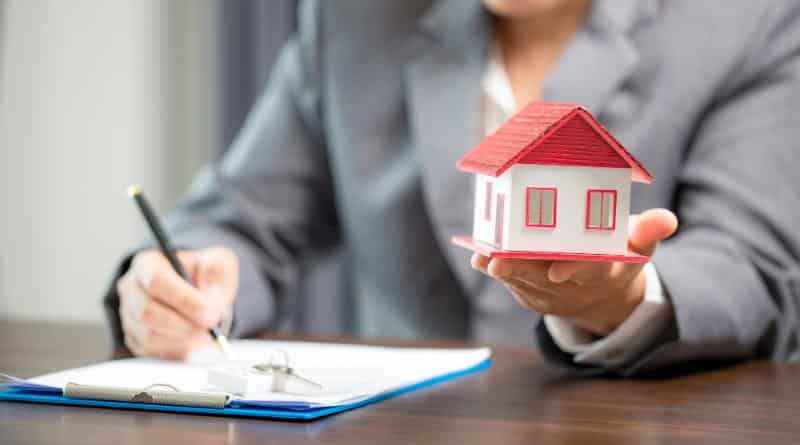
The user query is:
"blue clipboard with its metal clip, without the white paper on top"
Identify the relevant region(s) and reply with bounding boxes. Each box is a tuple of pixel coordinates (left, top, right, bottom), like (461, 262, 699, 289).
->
(0, 340, 491, 421)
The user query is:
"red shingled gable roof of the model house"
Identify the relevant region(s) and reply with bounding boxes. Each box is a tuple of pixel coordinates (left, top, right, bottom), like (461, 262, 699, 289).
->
(457, 102, 653, 184)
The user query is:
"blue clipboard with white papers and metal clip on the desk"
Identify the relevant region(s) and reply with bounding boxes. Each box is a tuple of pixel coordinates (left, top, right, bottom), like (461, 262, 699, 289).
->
(0, 340, 491, 420)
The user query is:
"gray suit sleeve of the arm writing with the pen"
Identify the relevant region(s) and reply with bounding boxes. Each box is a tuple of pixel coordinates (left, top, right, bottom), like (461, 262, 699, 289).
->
(105, 0, 339, 340)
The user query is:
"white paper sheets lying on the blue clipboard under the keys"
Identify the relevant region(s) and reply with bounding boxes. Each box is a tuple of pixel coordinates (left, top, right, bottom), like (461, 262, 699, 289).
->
(28, 340, 491, 406)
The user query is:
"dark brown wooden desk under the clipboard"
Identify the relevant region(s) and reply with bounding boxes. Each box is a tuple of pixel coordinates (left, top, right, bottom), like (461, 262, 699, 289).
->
(0, 321, 800, 445)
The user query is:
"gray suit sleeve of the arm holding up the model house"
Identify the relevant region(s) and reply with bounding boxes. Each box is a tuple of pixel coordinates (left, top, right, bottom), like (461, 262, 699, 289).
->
(537, 2, 800, 375)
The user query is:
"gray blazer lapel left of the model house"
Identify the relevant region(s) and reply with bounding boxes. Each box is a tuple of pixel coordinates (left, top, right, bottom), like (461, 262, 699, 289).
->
(406, 0, 490, 288)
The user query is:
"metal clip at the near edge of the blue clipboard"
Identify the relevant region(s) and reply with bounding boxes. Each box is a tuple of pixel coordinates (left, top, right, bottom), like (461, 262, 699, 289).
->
(63, 383, 232, 409)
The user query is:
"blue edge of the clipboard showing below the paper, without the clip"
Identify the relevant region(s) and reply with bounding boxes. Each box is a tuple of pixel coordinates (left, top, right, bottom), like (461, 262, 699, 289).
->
(0, 359, 492, 421)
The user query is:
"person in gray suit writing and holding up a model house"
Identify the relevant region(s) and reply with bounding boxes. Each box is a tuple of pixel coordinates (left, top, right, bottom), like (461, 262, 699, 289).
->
(107, 0, 800, 374)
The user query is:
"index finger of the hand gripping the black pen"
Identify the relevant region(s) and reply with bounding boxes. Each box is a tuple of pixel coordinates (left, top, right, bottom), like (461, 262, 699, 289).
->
(131, 251, 219, 328)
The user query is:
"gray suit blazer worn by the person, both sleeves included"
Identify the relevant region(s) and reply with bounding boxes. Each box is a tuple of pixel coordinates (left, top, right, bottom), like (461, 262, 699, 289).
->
(107, 0, 800, 374)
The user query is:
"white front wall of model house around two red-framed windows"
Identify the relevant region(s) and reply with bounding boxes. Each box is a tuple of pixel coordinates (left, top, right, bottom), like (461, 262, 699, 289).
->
(506, 164, 631, 254)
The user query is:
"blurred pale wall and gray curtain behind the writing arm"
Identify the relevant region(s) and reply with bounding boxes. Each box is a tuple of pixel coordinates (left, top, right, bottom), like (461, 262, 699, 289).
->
(0, 0, 295, 323)
